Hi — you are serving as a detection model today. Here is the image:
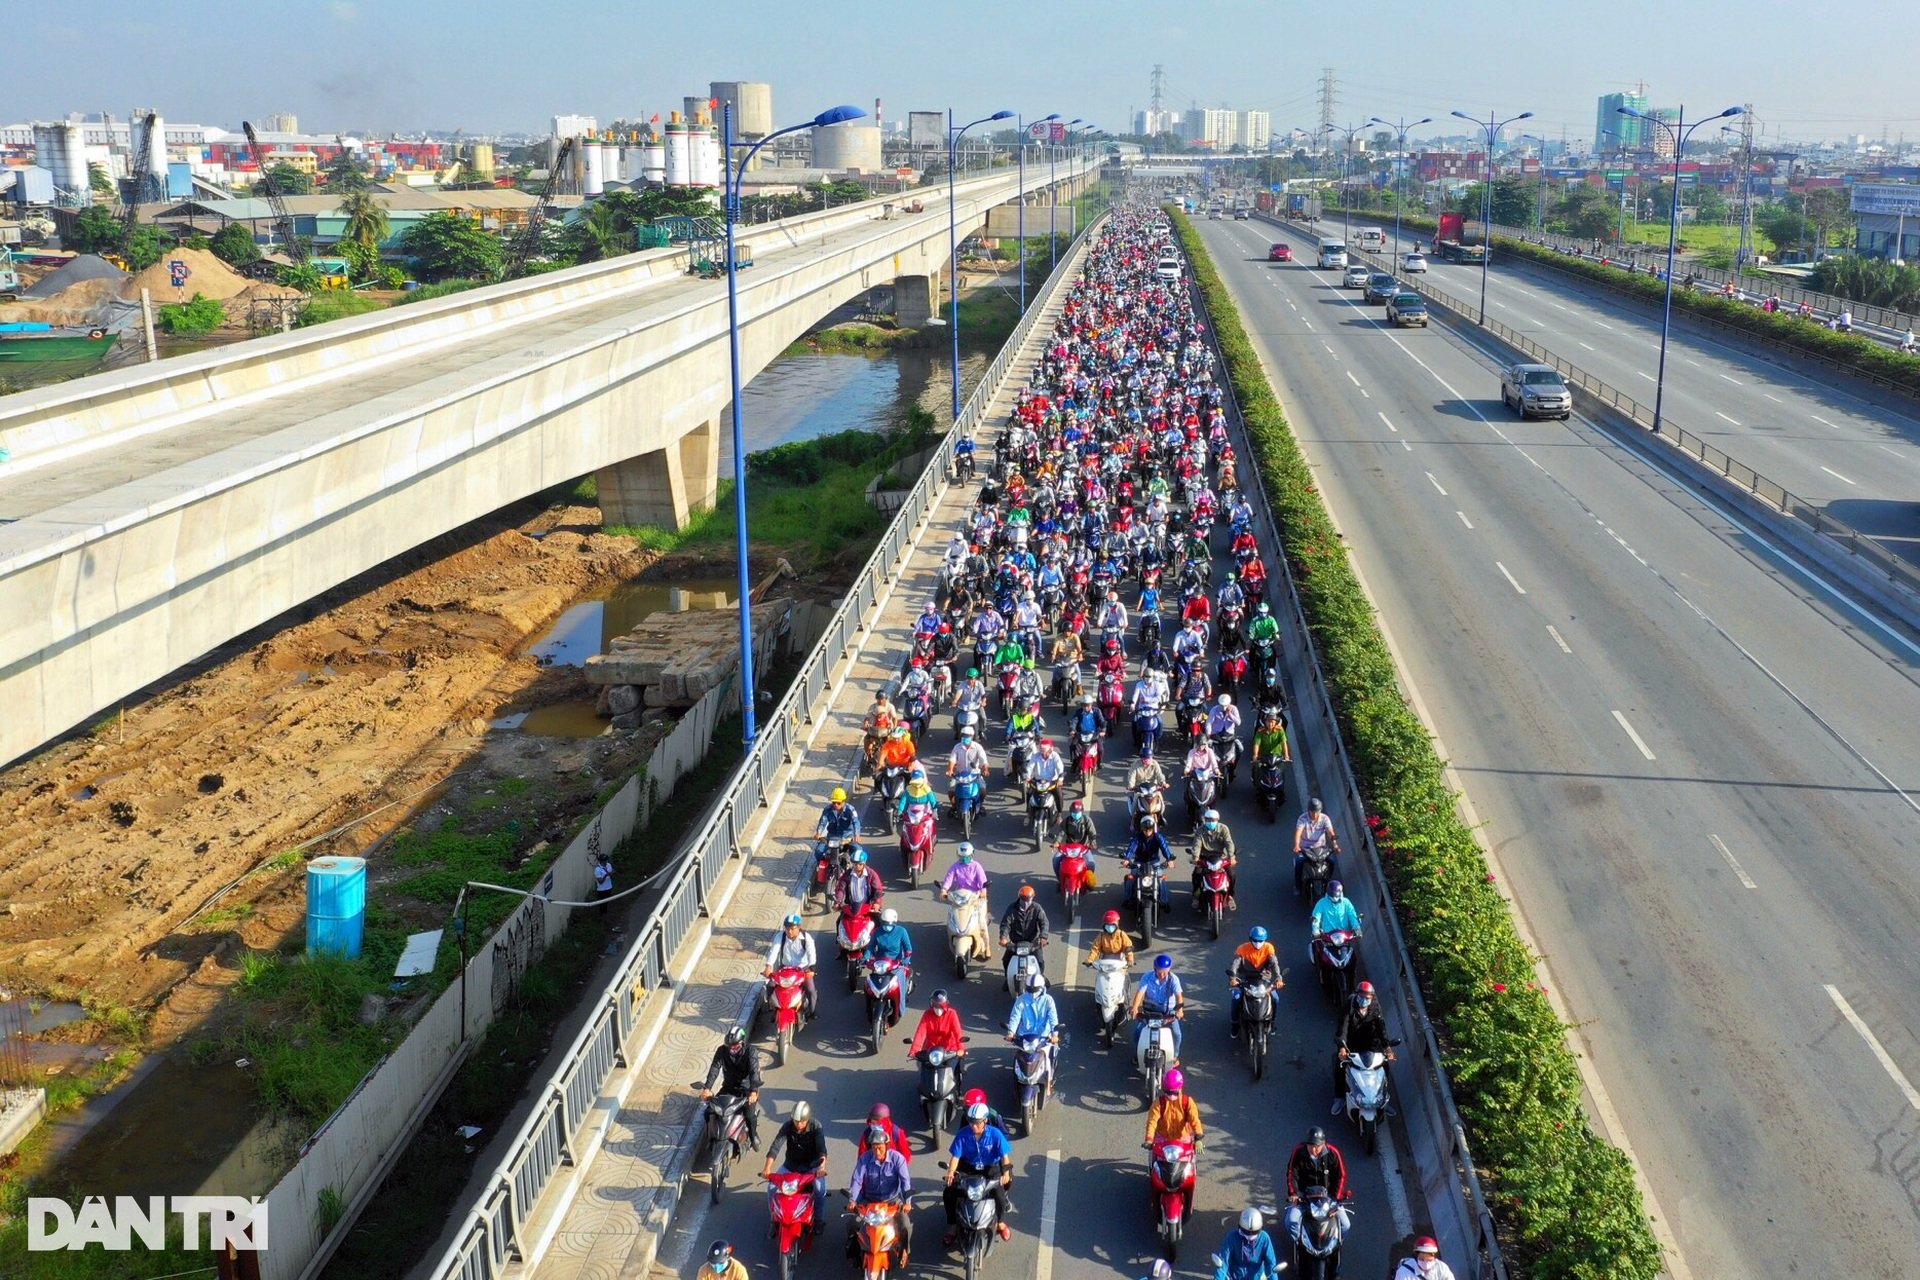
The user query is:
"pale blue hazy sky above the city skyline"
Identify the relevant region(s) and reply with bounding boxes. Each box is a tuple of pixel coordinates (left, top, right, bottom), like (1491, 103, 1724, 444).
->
(0, 0, 1920, 140)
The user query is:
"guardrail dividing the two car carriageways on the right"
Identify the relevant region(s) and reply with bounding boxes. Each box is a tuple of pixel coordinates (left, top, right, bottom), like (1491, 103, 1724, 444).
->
(1267, 219, 1920, 593)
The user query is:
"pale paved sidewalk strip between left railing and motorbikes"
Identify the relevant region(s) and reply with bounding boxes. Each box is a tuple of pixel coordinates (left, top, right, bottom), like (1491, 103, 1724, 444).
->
(520, 261, 1079, 1280)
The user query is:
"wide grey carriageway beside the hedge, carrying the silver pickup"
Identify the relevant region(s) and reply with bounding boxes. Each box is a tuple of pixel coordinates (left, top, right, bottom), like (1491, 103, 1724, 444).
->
(1202, 223, 1920, 1276)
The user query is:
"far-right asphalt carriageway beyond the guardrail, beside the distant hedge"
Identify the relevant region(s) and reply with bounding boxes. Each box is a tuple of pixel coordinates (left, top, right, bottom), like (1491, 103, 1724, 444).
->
(1282, 219, 1920, 535)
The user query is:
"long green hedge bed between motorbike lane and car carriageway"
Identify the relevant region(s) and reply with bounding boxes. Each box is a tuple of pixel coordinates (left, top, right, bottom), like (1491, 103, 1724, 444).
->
(1171, 211, 1661, 1280)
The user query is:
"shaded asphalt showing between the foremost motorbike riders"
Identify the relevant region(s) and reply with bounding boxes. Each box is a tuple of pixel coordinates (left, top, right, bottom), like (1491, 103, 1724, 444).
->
(660, 339, 1427, 1280)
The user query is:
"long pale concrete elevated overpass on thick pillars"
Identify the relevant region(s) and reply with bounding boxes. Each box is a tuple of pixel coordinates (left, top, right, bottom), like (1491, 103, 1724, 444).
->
(0, 163, 1096, 762)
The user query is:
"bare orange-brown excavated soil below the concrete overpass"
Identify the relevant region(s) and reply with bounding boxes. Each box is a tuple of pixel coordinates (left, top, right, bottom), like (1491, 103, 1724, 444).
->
(0, 507, 668, 1042)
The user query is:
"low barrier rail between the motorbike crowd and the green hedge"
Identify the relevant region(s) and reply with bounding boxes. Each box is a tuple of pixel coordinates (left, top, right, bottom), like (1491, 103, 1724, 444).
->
(1194, 220, 1507, 1280)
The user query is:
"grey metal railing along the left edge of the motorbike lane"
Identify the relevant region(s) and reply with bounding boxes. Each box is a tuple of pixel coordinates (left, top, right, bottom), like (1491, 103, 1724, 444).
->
(430, 208, 1106, 1280)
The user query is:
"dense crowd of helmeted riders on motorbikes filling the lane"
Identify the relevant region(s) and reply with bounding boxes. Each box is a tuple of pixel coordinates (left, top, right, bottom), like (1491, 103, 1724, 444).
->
(703, 205, 1443, 1280)
